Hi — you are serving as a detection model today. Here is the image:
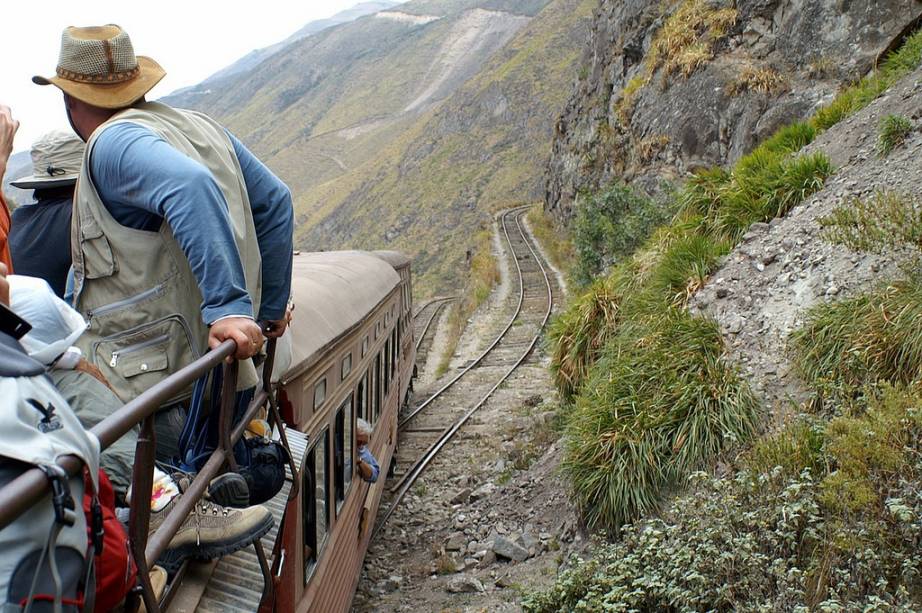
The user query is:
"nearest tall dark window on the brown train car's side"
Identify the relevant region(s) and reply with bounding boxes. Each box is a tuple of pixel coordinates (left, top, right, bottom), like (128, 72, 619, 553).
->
(301, 430, 330, 584)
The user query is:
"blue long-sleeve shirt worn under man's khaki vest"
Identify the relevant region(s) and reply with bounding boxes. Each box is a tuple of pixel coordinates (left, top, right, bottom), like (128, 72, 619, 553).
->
(90, 123, 294, 324)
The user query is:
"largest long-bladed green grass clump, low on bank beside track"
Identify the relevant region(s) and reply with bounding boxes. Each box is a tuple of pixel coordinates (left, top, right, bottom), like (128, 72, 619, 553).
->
(563, 308, 757, 530)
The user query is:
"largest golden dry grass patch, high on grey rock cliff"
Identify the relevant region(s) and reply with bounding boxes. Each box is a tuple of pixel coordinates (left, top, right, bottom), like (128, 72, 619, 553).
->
(647, 0, 739, 78)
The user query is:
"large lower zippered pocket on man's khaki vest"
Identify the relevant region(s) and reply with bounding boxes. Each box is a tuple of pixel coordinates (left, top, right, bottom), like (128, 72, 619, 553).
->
(92, 315, 198, 402)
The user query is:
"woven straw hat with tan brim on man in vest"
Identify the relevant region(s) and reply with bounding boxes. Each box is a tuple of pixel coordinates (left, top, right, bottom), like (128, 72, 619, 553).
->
(32, 24, 166, 109)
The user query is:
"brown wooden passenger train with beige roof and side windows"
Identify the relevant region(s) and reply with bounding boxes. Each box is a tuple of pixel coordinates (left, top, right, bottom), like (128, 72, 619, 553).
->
(276, 252, 415, 612)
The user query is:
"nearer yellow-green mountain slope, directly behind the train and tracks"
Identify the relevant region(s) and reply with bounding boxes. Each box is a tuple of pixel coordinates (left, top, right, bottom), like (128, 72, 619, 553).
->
(299, 0, 594, 287)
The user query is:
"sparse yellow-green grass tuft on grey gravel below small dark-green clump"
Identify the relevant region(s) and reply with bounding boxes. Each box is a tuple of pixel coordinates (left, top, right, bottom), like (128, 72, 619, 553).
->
(819, 191, 922, 253)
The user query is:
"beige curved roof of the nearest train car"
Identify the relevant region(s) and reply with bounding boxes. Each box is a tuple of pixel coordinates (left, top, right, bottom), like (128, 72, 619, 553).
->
(286, 251, 400, 376)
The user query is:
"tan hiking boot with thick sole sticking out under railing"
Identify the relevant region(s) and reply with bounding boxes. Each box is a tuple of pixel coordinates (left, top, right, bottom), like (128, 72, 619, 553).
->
(150, 495, 273, 574)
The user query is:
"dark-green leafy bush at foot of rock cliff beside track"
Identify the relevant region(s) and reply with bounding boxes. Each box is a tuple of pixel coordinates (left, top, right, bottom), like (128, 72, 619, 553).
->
(573, 183, 670, 286)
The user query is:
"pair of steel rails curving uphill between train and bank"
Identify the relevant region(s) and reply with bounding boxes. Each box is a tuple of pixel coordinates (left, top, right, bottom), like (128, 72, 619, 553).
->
(371, 207, 554, 539)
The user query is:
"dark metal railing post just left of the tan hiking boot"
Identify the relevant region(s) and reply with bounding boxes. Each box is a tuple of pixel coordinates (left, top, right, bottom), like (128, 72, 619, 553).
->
(128, 414, 160, 613)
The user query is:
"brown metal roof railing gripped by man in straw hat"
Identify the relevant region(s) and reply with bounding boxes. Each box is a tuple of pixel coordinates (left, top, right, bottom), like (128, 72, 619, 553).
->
(0, 339, 286, 613)
